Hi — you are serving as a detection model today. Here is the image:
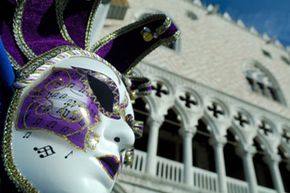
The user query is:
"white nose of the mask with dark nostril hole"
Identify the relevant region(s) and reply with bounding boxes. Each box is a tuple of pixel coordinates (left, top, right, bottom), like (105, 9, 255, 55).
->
(104, 116, 135, 151)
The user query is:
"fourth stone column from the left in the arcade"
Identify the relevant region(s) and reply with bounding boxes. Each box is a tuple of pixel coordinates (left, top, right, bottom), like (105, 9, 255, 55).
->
(237, 145, 258, 193)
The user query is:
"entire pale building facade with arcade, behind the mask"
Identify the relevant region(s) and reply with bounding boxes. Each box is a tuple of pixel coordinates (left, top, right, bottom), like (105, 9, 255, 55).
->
(100, 0, 290, 193)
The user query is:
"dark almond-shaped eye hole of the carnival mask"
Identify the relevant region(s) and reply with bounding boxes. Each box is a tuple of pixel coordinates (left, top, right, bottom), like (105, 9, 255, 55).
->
(88, 74, 114, 113)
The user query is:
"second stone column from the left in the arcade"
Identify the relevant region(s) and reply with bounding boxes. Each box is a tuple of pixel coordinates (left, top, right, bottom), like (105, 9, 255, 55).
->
(183, 128, 193, 186)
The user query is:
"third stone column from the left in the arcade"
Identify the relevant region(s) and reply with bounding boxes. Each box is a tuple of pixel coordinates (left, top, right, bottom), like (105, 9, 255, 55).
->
(210, 137, 228, 193)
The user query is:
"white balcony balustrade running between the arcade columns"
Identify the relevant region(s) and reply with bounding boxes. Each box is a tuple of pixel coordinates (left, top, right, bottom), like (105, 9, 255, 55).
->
(124, 150, 277, 193)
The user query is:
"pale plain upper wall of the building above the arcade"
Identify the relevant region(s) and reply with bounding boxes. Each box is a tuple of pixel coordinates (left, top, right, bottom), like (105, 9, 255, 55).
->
(102, 0, 290, 117)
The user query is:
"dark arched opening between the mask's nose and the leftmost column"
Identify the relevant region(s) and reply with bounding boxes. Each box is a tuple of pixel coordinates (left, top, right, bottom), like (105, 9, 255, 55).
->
(133, 98, 149, 152)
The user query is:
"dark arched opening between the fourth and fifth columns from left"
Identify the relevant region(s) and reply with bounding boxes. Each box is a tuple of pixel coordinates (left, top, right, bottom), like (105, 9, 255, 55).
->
(253, 138, 274, 189)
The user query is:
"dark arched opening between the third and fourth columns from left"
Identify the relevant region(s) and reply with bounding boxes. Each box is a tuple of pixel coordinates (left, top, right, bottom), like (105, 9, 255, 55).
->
(224, 129, 245, 180)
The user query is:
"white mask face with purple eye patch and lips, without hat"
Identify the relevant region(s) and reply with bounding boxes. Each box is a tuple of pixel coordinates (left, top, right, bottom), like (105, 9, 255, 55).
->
(4, 52, 135, 193)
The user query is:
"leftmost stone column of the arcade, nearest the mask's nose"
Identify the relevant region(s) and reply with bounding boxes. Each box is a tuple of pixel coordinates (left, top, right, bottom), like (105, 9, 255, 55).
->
(146, 117, 164, 176)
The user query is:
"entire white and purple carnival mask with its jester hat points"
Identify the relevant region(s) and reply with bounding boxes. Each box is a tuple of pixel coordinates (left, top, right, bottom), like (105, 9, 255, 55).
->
(2, 0, 178, 193)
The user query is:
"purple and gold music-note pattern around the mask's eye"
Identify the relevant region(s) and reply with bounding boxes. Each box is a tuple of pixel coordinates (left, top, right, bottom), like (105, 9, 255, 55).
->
(17, 68, 120, 150)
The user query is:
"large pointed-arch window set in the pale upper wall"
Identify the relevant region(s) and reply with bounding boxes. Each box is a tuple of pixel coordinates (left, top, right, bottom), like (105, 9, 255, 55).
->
(245, 61, 286, 104)
